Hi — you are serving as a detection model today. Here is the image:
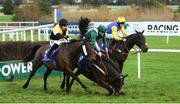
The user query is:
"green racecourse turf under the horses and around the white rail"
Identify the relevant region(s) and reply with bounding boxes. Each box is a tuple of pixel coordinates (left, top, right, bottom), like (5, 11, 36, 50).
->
(0, 36, 180, 103)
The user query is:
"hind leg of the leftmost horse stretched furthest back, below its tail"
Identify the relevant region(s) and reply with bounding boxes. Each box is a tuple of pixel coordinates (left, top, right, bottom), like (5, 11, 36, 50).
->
(23, 63, 42, 89)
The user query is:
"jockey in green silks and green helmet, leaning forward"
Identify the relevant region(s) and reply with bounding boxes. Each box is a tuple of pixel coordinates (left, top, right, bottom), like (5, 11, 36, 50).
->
(84, 25, 108, 57)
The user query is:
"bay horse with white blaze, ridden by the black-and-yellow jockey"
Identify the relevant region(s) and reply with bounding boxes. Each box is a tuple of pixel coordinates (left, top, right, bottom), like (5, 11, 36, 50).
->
(23, 40, 95, 92)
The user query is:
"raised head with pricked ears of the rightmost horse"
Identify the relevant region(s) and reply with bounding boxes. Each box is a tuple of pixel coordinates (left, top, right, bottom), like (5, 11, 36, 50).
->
(135, 30, 148, 52)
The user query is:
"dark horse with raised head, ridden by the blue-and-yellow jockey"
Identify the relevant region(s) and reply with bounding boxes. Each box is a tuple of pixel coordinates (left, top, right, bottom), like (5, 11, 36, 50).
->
(109, 31, 148, 73)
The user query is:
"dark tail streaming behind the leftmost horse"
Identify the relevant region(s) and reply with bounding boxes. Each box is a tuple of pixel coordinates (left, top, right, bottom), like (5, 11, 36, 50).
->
(23, 44, 41, 63)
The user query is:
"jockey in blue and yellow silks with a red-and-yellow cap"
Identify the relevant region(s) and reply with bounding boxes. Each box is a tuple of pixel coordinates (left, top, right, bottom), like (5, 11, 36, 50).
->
(107, 17, 127, 41)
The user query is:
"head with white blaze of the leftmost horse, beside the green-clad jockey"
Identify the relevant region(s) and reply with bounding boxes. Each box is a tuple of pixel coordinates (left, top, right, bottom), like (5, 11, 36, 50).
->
(82, 40, 96, 62)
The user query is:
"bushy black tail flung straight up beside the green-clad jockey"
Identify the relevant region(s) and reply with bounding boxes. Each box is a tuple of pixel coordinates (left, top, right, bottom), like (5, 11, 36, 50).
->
(79, 17, 91, 39)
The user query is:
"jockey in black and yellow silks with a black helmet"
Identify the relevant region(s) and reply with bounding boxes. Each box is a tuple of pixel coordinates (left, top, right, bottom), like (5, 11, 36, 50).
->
(47, 18, 69, 58)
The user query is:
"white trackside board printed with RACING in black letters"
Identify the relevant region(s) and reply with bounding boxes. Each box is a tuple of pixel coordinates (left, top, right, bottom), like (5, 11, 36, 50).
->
(143, 22, 180, 36)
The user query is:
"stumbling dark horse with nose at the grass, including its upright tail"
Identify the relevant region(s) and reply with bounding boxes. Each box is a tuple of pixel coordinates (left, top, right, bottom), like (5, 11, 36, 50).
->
(61, 18, 126, 95)
